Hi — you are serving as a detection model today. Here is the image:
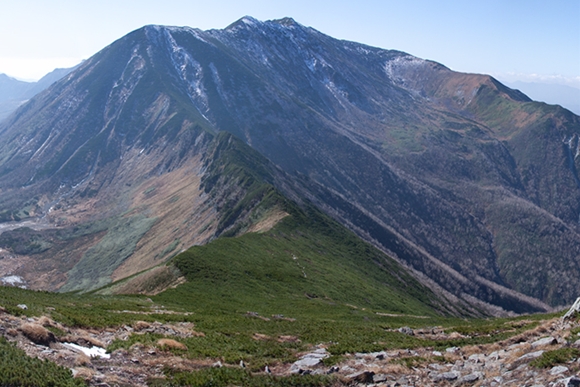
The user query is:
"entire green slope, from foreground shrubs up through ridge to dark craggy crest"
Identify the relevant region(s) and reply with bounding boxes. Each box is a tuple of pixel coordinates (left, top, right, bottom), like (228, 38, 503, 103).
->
(0, 134, 552, 385)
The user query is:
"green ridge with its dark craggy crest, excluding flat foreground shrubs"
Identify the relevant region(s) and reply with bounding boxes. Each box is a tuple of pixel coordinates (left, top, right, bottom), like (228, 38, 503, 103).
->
(163, 134, 444, 315)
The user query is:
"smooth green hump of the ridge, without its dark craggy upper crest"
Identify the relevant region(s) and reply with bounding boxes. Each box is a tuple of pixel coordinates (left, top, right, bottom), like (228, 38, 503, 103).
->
(165, 205, 435, 315)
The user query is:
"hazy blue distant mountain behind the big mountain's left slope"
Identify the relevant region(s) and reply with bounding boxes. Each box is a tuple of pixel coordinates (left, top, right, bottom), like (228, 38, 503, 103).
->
(0, 67, 74, 121)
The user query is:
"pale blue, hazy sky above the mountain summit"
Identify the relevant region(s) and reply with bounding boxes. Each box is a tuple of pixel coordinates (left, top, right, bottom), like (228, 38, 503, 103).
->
(0, 0, 580, 88)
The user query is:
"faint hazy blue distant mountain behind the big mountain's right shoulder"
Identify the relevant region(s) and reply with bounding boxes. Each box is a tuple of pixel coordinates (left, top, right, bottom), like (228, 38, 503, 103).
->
(506, 81, 580, 114)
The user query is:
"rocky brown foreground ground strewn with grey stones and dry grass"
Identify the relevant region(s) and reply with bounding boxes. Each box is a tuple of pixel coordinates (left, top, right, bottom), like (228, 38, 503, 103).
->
(0, 304, 580, 387)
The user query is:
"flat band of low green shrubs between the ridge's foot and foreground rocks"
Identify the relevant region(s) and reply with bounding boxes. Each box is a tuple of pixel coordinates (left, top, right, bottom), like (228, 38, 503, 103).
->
(0, 284, 545, 386)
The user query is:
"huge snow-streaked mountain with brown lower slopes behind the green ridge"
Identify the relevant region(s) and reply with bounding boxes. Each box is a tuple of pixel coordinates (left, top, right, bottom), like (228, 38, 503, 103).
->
(0, 17, 580, 312)
